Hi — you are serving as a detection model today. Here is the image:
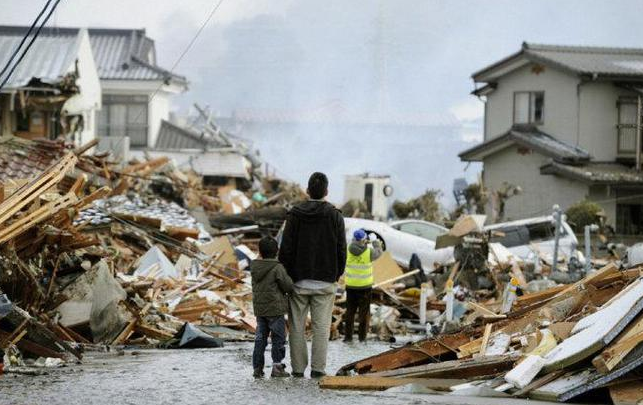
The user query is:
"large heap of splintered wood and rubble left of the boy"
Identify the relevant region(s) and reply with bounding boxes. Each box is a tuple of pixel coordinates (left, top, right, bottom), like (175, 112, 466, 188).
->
(0, 138, 301, 372)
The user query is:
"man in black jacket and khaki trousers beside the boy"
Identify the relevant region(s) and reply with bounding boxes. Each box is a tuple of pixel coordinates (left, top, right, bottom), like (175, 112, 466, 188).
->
(279, 172, 346, 378)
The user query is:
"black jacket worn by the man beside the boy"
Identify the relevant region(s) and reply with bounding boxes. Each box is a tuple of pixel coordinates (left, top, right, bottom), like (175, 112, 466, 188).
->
(279, 200, 346, 283)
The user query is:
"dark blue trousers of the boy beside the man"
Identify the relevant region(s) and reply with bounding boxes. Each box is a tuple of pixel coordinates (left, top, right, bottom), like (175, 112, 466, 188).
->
(252, 315, 286, 369)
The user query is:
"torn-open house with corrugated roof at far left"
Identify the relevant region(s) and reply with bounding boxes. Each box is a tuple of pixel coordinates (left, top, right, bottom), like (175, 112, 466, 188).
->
(0, 27, 101, 145)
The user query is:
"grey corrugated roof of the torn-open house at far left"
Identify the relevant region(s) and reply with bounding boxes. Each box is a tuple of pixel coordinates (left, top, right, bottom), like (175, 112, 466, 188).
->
(0, 30, 79, 89)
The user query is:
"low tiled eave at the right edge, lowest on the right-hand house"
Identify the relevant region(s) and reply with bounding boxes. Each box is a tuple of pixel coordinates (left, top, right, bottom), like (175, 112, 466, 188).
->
(540, 161, 643, 185)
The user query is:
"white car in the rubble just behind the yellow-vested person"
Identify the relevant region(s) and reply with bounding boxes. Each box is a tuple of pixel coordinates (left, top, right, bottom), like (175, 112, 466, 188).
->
(344, 218, 453, 271)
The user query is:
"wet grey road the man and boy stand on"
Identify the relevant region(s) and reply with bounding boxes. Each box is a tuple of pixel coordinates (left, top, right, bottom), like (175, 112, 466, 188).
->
(0, 342, 568, 405)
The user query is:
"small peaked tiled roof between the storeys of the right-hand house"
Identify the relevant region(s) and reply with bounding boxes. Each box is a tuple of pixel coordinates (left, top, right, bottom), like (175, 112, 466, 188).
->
(458, 126, 590, 163)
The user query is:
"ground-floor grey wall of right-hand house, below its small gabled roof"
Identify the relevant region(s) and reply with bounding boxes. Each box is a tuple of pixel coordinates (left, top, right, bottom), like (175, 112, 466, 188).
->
(483, 147, 589, 220)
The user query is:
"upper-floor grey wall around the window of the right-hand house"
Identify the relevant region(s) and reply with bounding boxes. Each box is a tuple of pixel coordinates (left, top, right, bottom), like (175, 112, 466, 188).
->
(485, 64, 579, 144)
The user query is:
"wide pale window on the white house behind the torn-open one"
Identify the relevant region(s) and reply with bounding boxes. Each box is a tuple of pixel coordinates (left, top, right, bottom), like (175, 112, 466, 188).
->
(97, 95, 148, 146)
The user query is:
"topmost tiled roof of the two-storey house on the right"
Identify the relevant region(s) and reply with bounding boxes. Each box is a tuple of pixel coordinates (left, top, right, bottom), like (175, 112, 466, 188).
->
(472, 42, 643, 82)
